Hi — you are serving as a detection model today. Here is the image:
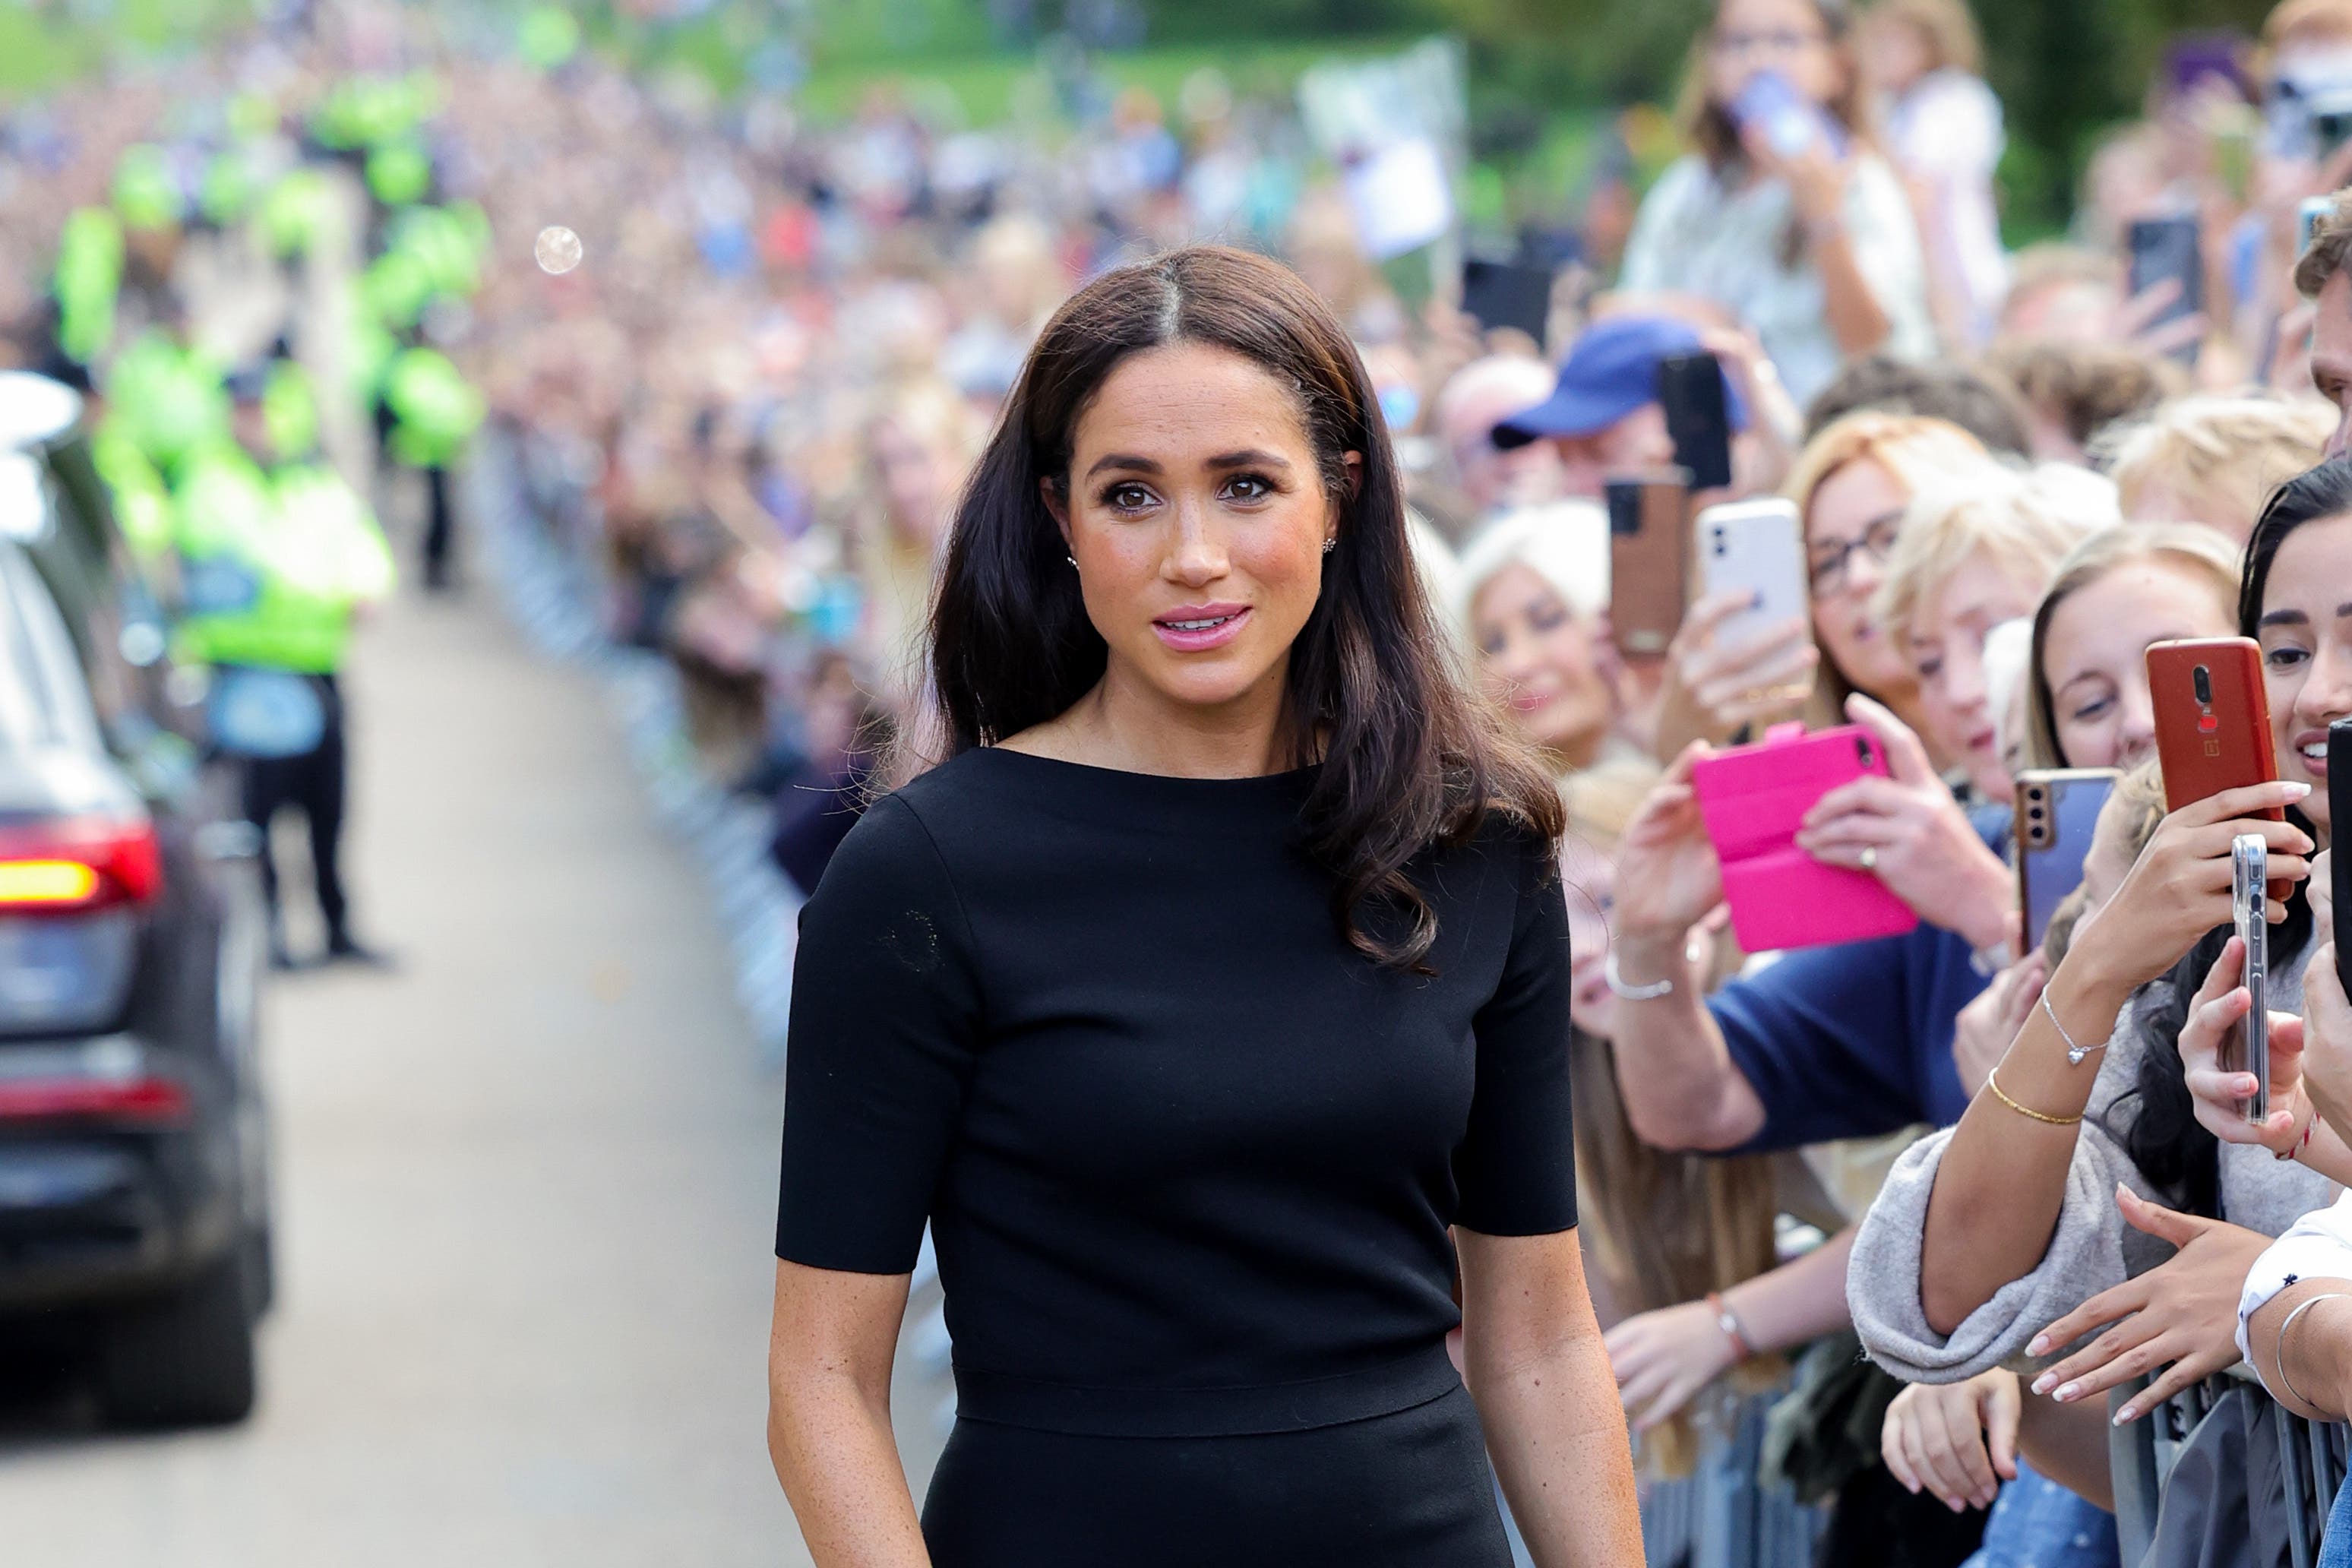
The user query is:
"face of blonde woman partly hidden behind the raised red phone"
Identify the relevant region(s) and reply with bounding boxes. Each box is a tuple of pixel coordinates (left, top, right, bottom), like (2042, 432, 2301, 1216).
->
(2041, 559, 2237, 769)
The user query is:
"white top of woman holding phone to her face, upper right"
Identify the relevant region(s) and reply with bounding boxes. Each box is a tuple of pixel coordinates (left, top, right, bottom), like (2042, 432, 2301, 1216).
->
(1618, 153, 1936, 404)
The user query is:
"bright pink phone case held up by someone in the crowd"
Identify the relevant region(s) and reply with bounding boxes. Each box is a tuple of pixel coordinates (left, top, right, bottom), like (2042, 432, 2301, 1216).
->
(1691, 724, 1919, 952)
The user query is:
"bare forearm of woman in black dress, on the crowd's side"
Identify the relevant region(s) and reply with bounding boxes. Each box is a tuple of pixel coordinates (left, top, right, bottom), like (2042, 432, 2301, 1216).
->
(1453, 1229, 1642, 1568)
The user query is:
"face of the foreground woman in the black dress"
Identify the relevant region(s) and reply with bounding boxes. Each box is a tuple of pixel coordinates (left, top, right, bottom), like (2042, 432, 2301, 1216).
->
(1047, 343, 1362, 710)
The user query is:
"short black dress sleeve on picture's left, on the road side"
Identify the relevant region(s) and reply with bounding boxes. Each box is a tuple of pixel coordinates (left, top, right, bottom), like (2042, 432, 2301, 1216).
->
(776, 797, 981, 1274)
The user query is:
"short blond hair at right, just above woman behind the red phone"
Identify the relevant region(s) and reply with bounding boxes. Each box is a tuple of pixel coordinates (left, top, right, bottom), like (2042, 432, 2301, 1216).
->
(2098, 393, 2335, 529)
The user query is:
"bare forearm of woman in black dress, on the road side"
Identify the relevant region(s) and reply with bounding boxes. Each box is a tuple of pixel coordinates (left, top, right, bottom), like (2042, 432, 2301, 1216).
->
(767, 1260, 931, 1568)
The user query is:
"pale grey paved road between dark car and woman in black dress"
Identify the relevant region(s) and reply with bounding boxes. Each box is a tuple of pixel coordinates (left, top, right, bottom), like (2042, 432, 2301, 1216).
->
(0, 576, 846, 1568)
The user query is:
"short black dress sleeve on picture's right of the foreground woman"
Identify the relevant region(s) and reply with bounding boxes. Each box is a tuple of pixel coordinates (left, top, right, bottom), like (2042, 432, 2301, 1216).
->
(1453, 842, 1576, 1237)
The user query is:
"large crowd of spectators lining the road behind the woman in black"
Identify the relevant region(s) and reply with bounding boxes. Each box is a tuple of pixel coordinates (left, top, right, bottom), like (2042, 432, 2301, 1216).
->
(32, 0, 2352, 1568)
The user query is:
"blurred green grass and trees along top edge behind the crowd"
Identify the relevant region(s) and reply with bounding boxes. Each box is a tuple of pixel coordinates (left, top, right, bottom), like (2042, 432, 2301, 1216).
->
(0, 0, 2314, 240)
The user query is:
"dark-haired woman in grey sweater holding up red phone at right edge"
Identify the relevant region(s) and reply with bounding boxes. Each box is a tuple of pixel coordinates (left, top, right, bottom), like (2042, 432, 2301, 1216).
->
(1848, 461, 2352, 1420)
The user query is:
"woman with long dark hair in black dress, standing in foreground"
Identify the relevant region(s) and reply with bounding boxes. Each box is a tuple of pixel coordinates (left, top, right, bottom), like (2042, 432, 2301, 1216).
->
(769, 247, 1642, 1568)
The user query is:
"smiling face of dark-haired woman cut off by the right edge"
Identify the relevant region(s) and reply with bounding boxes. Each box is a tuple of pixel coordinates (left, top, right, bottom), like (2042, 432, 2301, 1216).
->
(2256, 515, 2352, 844)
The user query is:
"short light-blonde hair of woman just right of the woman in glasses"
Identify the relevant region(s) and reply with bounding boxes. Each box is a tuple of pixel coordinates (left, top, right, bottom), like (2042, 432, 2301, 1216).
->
(1872, 458, 2122, 649)
